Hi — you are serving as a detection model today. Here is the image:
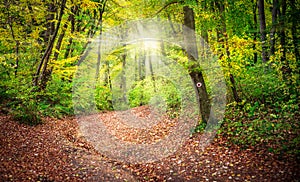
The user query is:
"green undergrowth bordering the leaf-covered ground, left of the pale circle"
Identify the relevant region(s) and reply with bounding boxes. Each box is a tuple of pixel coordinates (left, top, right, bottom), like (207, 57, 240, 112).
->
(0, 72, 73, 125)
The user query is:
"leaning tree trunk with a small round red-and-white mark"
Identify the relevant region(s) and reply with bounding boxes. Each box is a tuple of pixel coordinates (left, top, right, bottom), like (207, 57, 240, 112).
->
(183, 6, 210, 123)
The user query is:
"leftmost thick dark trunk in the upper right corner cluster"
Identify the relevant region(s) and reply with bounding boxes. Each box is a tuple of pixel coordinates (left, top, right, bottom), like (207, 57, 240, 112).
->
(258, 0, 268, 63)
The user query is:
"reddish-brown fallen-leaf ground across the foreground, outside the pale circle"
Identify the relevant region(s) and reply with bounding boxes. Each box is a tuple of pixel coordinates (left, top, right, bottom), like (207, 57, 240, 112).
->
(0, 107, 300, 182)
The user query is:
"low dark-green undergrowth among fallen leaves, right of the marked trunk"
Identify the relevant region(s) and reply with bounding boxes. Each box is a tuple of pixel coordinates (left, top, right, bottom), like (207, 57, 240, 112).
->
(220, 99, 300, 154)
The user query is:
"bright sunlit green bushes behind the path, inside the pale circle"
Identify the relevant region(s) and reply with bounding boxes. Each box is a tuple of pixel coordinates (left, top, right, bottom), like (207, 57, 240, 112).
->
(95, 76, 181, 116)
